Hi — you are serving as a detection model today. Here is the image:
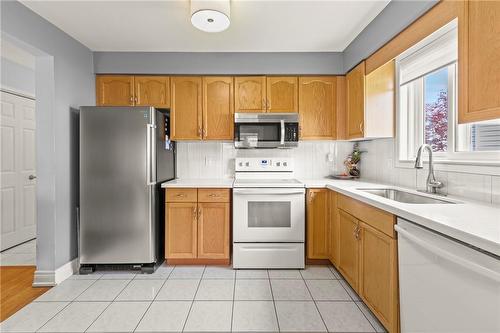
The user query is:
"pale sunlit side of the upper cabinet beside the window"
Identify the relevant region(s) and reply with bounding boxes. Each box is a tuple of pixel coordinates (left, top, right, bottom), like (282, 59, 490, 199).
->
(363, 60, 396, 138)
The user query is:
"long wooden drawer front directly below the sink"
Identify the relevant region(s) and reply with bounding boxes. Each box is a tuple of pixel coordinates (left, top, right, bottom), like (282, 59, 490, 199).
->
(337, 194, 396, 238)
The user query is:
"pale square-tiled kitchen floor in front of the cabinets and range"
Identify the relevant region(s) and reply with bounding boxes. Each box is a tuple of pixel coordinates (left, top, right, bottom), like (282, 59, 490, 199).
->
(0, 266, 384, 332)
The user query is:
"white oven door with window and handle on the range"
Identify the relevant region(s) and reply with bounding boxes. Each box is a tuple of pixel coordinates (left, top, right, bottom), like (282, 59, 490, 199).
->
(233, 188, 305, 243)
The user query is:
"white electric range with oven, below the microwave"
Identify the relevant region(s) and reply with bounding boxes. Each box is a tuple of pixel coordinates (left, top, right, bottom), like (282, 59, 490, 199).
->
(233, 158, 305, 268)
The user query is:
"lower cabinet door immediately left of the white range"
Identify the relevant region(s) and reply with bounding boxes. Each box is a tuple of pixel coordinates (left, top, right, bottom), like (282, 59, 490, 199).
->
(198, 202, 230, 259)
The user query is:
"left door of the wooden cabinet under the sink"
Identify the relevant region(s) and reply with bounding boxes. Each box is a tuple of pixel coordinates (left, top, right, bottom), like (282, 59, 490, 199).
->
(338, 209, 359, 291)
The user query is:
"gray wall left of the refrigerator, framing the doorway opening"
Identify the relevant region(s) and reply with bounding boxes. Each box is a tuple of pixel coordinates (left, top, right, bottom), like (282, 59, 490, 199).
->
(0, 1, 95, 271)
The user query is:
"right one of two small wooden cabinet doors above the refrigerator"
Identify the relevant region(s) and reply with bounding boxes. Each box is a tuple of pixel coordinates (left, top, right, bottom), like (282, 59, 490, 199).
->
(134, 76, 170, 108)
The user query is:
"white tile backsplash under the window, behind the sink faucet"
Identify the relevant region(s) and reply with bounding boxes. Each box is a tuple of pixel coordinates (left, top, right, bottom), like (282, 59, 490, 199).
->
(360, 139, 500, 205)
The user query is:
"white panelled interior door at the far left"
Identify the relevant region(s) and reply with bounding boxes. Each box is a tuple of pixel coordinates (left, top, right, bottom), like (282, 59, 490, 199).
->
(0, 92, 36, 250)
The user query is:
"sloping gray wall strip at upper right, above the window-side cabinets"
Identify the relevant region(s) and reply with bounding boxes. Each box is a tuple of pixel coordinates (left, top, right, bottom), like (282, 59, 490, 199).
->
(343, 0, 439, 73)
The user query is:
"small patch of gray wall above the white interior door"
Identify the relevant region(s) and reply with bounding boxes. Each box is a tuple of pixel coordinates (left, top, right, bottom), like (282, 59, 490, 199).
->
(0, 57, 35, 96)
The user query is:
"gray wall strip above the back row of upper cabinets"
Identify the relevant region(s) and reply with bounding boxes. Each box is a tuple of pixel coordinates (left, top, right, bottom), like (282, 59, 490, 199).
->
(94, 52, 343, 75)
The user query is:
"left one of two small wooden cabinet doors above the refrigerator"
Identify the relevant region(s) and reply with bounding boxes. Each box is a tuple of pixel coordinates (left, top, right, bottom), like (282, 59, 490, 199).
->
(96, 75, 134, 106)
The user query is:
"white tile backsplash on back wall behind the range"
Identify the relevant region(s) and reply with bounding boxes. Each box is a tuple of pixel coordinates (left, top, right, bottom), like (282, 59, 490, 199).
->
(177, 141, 352, 179)
